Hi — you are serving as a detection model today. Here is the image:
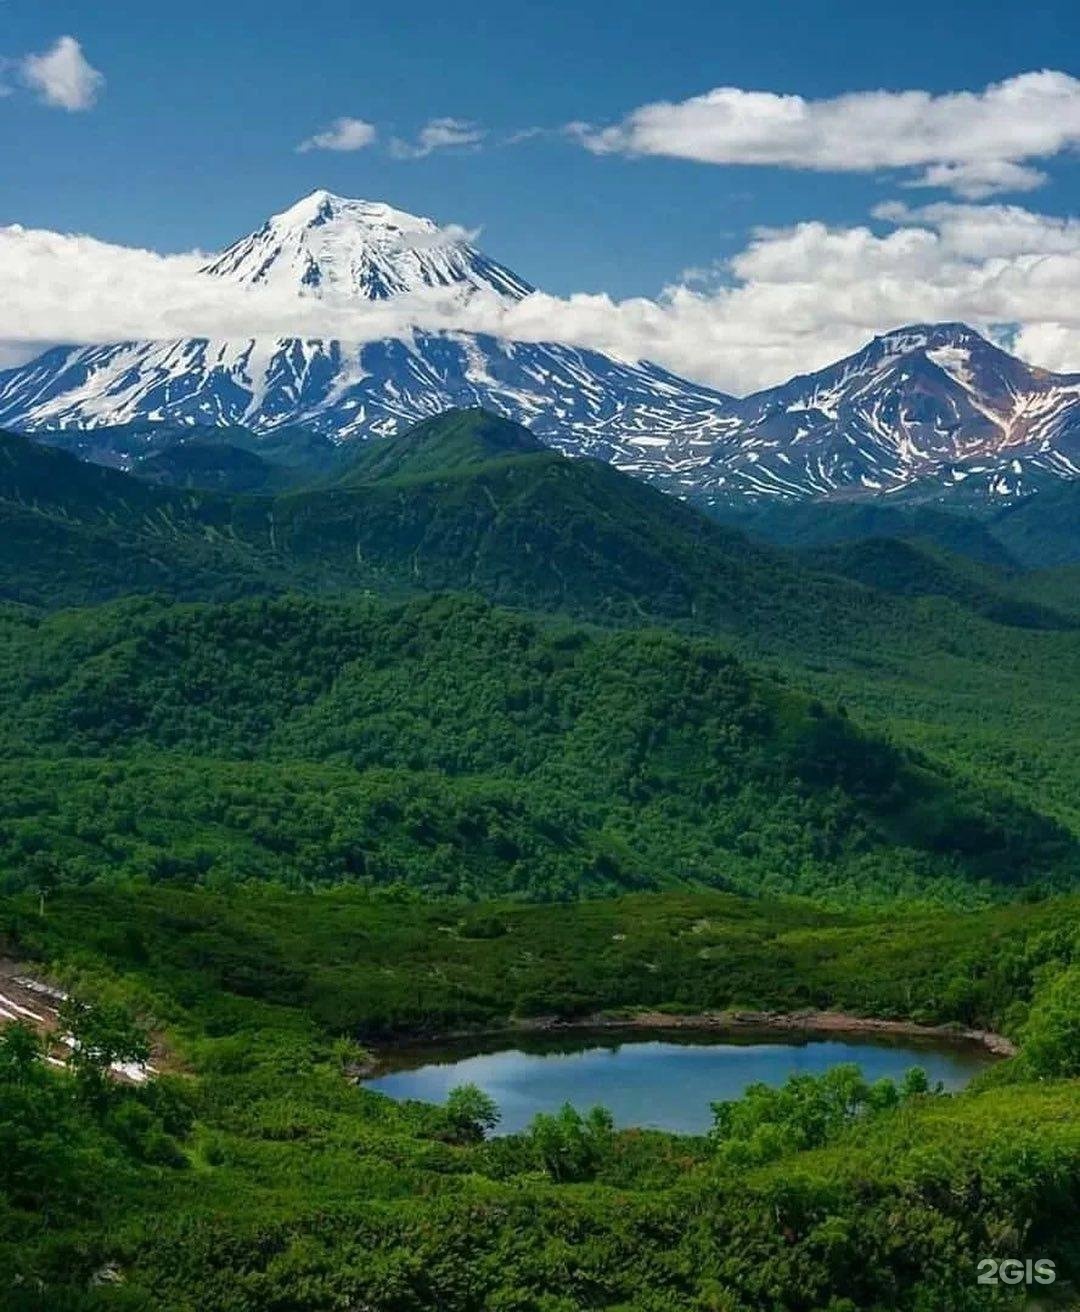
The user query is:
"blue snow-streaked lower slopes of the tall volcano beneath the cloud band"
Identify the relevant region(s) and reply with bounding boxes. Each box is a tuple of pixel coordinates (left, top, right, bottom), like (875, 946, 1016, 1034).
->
(0, 333, 732, 470)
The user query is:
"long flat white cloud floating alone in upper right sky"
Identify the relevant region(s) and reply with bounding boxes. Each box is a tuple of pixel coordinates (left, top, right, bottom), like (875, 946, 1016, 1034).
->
(568, 70, 1080, 198)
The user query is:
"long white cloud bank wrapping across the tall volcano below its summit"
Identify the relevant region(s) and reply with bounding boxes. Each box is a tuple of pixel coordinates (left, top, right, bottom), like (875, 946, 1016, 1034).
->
(0, 194, 1080, 394)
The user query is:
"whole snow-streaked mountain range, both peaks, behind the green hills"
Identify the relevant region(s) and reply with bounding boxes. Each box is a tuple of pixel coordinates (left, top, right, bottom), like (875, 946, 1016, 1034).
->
(0, 192, 1080, 505)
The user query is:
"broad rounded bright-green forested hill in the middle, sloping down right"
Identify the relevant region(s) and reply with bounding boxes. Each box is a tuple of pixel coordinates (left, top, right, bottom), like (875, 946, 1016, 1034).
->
(0, 597, 1076, 900)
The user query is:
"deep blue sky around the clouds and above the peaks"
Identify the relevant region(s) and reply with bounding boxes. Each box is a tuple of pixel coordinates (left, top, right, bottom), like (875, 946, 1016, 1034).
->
(0, 0, 1080, 297)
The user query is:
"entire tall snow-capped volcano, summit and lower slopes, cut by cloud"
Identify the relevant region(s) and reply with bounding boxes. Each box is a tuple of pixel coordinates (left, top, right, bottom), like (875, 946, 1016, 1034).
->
(0, 192, 728, 467)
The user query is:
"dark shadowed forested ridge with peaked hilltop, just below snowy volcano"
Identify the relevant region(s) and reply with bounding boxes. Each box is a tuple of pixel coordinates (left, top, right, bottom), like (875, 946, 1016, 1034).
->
(0, 411, 923, 647)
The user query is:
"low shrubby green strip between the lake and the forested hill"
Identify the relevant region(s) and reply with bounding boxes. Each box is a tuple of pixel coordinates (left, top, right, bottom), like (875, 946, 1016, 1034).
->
(19, 886, 1080, 1039)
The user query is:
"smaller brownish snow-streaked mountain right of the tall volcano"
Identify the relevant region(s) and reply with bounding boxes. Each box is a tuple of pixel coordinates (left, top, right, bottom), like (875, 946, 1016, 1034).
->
(666, 324, 1080, 502)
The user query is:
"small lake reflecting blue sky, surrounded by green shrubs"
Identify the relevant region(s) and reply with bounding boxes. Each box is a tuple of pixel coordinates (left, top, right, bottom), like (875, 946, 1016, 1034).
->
(363, 1030, 993, 1134)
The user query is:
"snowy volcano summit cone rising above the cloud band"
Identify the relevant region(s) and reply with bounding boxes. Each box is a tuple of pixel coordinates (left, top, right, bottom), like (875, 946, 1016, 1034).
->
(202, 192, 533, 303)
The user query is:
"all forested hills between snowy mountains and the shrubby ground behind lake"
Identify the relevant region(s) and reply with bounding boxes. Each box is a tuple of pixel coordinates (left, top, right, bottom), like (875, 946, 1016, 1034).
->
(0, 412, 1080, 897)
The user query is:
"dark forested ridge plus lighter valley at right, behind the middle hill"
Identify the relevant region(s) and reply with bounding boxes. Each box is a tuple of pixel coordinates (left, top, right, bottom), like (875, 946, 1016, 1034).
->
(0, 412, 1080, 850)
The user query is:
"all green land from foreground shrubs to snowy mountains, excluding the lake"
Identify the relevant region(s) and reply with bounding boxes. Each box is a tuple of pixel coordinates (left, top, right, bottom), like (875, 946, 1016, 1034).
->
(0, 411, 1080, 1312)
